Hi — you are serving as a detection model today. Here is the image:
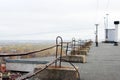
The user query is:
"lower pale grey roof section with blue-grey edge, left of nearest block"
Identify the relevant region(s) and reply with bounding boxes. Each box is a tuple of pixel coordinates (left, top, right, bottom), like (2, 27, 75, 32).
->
(6, 59, 48, 72)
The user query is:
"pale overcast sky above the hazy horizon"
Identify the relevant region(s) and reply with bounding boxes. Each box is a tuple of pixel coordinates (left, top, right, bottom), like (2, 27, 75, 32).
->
(0, 0, 120, 40)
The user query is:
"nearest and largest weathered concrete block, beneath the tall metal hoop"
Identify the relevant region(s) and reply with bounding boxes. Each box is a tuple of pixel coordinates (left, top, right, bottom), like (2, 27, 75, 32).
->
(31, 66, 80, 80)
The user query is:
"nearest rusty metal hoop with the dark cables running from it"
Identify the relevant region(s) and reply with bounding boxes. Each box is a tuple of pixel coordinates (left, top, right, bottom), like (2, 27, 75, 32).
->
(0, 36, 80, 80)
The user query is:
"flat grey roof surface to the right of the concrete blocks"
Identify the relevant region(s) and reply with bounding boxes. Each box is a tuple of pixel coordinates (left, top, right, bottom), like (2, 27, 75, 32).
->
(75, 43, 120, 80)
